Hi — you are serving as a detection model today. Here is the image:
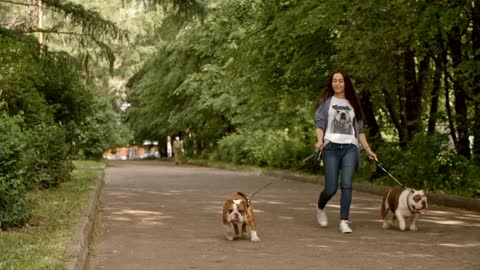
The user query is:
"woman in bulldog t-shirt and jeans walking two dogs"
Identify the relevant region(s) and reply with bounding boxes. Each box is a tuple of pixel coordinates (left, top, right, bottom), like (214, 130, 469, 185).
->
(315, 71, 377, 233)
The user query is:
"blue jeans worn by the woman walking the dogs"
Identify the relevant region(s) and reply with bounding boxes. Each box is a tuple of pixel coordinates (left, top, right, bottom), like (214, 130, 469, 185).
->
(318, 142, 358, 220)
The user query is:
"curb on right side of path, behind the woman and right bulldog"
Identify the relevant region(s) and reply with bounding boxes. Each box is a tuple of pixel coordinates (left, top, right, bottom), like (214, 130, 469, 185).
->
(262, 170, 480, 211)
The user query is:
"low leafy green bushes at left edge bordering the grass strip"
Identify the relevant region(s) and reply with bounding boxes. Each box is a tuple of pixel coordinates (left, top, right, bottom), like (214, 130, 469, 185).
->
(0, 112, 73, 229)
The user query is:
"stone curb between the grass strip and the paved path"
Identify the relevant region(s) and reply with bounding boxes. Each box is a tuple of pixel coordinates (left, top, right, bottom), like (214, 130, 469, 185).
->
(64, 168, 105, 270)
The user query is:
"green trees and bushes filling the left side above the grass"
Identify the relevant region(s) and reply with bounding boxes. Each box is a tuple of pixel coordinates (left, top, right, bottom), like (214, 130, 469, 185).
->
(0, 0, 133, 228)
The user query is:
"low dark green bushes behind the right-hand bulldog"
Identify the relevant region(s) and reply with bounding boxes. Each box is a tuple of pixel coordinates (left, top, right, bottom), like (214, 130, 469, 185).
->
(364, 134, 480, 198)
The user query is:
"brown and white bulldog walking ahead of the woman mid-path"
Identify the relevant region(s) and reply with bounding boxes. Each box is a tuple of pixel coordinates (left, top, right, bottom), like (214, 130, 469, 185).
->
(223, 192, 260, 241)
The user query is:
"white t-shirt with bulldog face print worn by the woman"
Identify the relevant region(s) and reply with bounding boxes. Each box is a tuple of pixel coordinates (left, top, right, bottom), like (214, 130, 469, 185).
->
(324, 96, 358, 146)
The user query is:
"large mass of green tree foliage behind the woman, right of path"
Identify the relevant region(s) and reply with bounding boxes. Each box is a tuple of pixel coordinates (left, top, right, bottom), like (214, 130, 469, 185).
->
(77, 0, 479, 196)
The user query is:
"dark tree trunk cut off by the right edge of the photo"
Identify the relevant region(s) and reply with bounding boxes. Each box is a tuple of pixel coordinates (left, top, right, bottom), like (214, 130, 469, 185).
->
(472, 1, 480, 163)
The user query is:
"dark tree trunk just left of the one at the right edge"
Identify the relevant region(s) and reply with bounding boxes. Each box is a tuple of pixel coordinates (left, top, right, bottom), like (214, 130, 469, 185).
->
(448, 27, 471, 158)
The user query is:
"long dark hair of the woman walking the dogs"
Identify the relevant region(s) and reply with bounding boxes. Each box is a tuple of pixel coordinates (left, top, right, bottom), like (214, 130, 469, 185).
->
(317, 69, 363, 120)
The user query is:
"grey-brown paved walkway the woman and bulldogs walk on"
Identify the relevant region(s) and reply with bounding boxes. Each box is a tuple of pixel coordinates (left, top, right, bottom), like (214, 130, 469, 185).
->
(90, 161, 480, 270)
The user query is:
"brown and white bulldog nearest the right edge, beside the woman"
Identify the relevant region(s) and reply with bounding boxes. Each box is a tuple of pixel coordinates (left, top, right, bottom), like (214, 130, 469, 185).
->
(382, 187, 428, 231)
